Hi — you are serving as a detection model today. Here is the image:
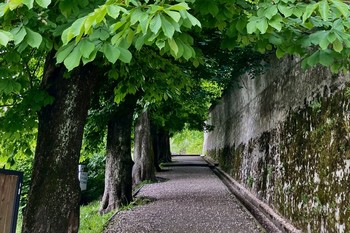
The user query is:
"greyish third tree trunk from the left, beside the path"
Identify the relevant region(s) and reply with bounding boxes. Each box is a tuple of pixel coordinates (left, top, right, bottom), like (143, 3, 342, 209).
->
(132, 112, 156, 185)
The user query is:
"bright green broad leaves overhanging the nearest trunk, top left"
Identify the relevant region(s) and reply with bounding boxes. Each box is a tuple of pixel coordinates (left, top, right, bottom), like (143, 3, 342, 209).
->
(0, 0, 201, 70)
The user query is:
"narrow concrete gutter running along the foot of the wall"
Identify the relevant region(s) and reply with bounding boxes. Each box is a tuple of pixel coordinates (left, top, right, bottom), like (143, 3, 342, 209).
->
(202, 156, 302, 233)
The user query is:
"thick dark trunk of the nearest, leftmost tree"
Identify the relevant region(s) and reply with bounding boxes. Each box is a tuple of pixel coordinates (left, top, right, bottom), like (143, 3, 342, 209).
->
(22, 53, 97, 233)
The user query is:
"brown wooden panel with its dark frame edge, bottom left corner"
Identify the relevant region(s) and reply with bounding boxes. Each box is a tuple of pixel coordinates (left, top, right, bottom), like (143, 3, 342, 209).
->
(0, 169, 23, 233)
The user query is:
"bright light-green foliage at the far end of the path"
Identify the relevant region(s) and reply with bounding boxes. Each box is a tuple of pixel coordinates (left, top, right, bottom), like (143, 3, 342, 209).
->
(170, 129, 204, 154)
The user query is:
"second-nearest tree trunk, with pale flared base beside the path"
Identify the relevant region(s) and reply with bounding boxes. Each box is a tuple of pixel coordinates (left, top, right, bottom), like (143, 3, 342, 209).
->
(100, 95, 137, 213)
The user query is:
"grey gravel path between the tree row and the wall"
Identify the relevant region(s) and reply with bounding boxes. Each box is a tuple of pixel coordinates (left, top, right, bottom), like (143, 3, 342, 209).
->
(105, 156, 265, 233)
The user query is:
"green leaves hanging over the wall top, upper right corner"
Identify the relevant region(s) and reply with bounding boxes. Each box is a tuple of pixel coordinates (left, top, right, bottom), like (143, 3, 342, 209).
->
(193, 0, 350, 72)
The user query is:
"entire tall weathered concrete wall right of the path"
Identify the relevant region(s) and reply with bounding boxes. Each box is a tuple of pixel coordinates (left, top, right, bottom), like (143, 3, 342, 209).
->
(203, 55, 350, 233)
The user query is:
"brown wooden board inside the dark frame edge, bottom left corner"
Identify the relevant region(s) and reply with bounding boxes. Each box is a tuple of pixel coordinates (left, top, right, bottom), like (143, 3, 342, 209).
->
(0, 174, 18, 233)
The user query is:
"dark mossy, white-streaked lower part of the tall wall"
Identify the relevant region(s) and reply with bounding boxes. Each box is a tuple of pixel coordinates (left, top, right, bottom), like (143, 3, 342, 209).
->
(207, 84, 350, 233)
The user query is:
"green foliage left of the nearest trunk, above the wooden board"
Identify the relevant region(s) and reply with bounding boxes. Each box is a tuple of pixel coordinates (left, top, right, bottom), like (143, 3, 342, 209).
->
(0, 50, 47, 166)
